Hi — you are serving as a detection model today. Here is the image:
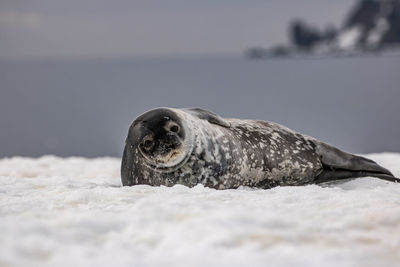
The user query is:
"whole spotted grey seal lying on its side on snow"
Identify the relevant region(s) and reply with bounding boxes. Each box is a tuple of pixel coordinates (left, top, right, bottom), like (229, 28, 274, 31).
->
(121, 108, 400, 189)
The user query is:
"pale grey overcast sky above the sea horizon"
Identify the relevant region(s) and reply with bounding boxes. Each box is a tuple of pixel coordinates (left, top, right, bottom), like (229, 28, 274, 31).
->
(0, 0, 355, 58)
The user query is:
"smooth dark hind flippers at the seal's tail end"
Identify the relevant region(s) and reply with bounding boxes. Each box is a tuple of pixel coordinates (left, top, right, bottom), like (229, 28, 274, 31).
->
(315, 142, 400, 183)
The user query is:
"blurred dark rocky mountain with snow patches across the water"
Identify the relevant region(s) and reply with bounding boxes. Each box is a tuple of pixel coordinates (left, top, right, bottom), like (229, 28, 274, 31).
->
(247, 0, 400, 58)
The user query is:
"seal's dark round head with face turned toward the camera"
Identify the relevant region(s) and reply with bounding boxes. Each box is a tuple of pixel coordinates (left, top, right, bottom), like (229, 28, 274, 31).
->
(121, 108, 192, 184)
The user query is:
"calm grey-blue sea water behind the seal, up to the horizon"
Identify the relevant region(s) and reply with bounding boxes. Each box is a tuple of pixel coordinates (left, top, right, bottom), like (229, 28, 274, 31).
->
(0, 55, 400, 157)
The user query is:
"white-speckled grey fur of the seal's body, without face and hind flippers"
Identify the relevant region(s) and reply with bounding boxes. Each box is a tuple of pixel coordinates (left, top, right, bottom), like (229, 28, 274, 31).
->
(121, 108, 396, 189)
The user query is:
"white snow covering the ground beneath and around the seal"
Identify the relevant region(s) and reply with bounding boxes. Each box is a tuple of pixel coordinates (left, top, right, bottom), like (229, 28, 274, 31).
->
(0, 153, 400, 267)
